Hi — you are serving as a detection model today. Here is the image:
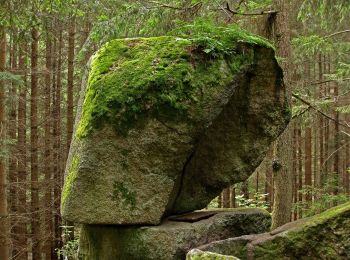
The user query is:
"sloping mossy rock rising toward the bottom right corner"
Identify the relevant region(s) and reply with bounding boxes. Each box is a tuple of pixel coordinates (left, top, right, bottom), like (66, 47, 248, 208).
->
(193, 203, 350, 260)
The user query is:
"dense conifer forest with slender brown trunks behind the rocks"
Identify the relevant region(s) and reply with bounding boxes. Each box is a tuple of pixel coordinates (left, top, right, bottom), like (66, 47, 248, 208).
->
(0, 0, 350, 259)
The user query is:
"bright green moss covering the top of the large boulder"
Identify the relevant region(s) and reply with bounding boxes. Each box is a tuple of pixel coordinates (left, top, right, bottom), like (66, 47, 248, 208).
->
(76, 24, 271, 139)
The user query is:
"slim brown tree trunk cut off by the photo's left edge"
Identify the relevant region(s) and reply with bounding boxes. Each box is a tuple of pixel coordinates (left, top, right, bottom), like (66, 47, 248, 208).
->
(0, 25, 9, 260)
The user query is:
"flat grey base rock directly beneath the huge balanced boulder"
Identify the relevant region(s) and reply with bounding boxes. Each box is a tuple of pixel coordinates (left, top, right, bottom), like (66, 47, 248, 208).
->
(80, 209, 271, 260)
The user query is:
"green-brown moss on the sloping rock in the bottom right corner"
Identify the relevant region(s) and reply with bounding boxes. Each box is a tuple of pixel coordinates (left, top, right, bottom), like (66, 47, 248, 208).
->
(254, 203, 350, 259)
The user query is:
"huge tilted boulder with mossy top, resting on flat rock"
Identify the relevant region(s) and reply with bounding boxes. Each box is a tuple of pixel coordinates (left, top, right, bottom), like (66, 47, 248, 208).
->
(62, 28, 290, 224)
